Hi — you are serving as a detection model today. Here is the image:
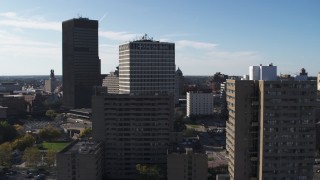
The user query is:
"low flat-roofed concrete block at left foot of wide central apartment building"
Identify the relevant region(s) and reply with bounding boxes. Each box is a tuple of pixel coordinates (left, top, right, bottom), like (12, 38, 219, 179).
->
(56, 140, 103, 180)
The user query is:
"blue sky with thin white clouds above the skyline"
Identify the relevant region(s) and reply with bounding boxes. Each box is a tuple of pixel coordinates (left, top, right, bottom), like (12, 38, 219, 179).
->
(0, 0, 320, 76)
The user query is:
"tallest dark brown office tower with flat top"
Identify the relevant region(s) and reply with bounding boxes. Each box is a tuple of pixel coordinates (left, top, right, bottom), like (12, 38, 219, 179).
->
(62, 18, 101, 108)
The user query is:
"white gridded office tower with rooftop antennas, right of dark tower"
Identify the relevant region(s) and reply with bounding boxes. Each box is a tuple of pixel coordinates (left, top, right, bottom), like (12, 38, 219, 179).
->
(119, 35, 175, 94)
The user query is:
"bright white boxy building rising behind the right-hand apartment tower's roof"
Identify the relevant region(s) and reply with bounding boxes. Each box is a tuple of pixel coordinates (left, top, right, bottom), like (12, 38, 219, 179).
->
(249, 63, 277, 81)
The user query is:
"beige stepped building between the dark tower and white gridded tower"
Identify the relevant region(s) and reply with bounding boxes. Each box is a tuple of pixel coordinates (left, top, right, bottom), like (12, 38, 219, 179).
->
(102, 67, 119, 94)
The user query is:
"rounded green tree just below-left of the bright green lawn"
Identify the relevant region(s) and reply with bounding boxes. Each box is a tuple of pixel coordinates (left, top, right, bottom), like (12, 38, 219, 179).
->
(22, 147, 41, 167)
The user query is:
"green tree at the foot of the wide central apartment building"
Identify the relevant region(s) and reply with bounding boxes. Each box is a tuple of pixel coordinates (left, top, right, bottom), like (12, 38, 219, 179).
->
(136, 164, 165, 180)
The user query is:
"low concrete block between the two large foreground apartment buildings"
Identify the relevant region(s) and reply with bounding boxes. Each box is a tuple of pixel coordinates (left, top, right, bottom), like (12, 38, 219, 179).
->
(167, 148, 208, 180)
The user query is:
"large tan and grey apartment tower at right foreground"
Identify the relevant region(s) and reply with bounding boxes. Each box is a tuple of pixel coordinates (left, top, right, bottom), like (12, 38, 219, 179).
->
(226, 66, 316, 180)
